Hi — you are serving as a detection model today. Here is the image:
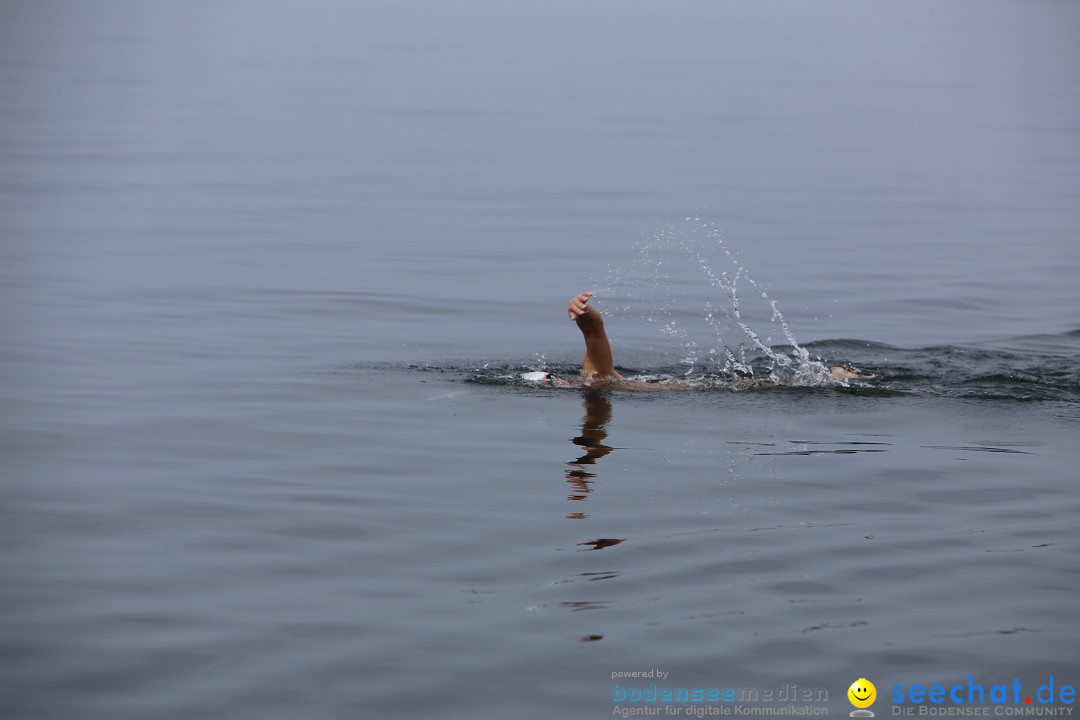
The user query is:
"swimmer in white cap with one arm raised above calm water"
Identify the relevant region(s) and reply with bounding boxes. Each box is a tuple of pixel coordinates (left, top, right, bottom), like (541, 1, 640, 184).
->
(523, 291, 874, 391)
